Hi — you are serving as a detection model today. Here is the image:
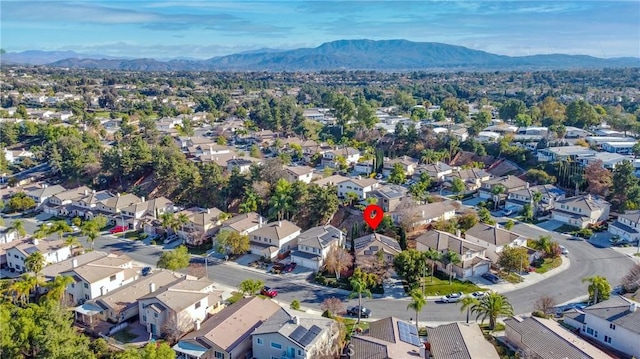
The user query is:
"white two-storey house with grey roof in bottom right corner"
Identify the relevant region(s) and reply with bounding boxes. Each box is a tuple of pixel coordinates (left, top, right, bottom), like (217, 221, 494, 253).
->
(565, 296, 640, 358)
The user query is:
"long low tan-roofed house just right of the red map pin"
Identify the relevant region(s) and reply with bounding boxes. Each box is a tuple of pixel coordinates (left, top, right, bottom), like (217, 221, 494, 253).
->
(391, 201, 456, 228)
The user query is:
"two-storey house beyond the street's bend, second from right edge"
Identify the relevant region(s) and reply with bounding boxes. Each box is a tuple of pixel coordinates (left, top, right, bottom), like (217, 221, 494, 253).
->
(551, 194, 610, 228)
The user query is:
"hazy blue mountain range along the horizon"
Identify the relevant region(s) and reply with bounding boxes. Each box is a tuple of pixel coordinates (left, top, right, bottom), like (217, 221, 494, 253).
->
(0, 40, 640, 71)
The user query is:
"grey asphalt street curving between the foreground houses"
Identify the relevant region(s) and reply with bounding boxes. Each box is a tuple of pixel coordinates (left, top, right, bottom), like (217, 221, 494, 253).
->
(5, 215, 633, 322)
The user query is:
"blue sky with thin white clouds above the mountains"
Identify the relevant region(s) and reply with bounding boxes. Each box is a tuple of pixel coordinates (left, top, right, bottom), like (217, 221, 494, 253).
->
(0, 0, 640, 58)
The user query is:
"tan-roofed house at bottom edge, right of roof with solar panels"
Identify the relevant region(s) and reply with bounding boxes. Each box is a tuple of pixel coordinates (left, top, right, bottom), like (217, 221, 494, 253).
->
(427, 323, 500, 359)
